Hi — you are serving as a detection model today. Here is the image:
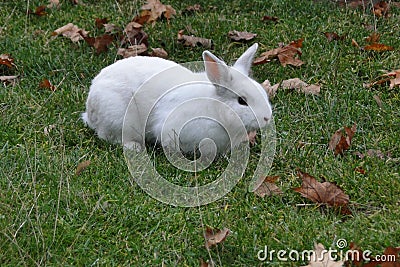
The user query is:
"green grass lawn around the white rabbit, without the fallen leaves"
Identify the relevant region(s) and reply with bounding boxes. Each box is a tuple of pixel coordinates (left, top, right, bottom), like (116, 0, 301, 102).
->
(0, 0, 400, 266)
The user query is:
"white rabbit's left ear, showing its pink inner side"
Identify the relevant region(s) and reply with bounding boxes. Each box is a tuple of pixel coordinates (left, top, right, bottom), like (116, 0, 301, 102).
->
(203, 51, 231, 84)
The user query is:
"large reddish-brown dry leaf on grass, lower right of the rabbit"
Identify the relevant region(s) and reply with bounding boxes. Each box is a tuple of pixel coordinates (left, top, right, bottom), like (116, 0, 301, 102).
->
(293, 170, 351, 214)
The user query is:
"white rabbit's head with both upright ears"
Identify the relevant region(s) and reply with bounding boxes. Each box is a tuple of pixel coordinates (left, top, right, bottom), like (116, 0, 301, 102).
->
(203, 44, 272, 135)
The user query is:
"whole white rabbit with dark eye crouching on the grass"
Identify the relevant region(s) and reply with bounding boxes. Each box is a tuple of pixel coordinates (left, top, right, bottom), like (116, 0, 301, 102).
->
(82, 44, 272, 157)
